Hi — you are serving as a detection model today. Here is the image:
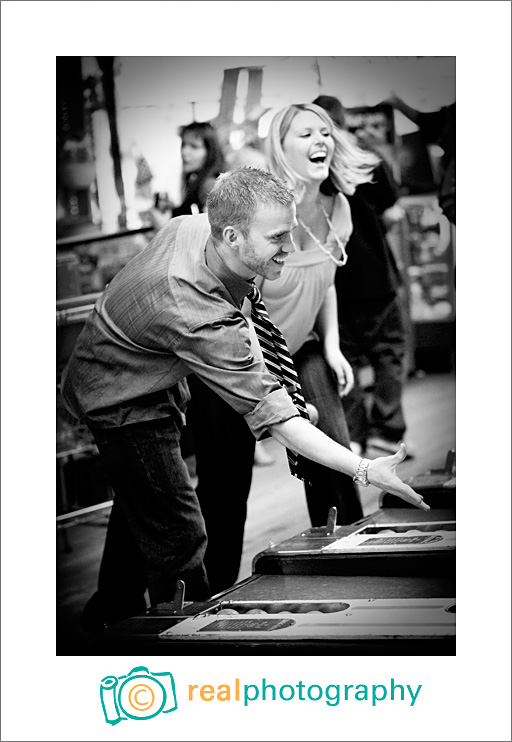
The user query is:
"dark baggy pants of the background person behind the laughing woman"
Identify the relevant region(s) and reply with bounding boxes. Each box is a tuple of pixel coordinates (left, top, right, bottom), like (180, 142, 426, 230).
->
(338, 297, 405, 448)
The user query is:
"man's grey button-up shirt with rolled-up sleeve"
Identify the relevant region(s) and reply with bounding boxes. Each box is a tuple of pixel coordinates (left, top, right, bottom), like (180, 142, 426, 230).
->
(62, 214, 299, 438)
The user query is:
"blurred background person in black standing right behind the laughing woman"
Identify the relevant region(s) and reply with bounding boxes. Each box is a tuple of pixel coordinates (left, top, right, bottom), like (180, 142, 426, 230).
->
(315, 95, 412, 458)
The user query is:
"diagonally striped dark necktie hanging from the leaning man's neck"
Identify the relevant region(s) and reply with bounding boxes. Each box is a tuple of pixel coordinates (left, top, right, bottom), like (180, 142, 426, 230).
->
(247, 286, 309, 481)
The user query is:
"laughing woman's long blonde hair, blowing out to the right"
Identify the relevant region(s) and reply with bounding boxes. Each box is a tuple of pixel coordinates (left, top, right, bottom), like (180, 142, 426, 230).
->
(265, 103, 380, 202)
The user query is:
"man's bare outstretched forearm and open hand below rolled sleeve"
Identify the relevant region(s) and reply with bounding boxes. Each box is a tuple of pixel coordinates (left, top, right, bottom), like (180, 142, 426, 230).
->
(270, 417, 430, 510)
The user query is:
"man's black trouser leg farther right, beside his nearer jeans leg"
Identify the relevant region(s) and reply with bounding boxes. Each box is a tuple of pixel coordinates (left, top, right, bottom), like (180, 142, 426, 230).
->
(187, 375, 256, 595)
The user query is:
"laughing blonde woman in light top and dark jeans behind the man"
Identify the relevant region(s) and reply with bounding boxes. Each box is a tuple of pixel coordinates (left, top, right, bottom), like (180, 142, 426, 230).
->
(259, 104, 378, 526)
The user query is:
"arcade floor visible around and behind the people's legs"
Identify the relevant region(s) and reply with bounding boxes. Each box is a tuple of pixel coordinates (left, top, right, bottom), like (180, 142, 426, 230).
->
(56, 373, 455, 655)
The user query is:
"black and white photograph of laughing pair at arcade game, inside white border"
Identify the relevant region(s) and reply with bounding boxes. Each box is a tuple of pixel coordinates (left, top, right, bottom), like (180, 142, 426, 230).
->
(56, 57, 456, 655)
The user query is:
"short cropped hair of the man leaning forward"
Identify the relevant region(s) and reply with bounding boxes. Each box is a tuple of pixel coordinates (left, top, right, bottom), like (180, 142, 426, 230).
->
(206, 167, 294, 240)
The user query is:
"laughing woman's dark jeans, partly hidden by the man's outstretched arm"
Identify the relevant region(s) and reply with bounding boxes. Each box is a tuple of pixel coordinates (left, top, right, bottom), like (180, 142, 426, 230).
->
(293, 340, 363, 526)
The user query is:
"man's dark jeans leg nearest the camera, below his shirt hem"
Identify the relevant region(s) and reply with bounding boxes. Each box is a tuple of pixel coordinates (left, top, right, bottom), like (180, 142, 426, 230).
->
(93, 416, 210, 615)
